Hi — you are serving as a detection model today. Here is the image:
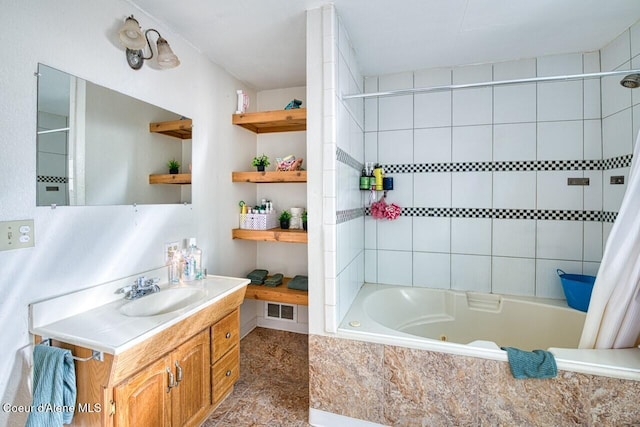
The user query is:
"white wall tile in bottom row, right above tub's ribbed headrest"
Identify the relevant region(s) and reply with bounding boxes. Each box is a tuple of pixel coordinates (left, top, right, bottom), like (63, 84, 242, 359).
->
(451, 254, 491, 292)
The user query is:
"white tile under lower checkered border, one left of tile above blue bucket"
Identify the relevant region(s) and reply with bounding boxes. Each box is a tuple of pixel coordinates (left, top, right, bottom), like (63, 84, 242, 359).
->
(492, 219, 536, 258)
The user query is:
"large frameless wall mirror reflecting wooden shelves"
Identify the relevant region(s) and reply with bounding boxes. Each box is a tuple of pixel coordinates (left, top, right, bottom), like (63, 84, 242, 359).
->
(36, 64, 191, 206)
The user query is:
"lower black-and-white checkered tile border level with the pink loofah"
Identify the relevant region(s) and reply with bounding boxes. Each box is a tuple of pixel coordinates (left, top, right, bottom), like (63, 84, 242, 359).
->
(365, 208, 618, 222)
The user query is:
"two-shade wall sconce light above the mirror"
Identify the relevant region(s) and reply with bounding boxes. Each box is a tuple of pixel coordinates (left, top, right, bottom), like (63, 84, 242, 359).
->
(118, 15, 180, 70)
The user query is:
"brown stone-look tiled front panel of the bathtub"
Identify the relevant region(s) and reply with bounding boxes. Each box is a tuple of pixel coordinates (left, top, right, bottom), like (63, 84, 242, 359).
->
(309, 335, 640, 426)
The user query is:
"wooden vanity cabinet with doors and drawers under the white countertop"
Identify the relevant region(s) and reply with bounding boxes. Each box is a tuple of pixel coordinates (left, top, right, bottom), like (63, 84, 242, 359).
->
(55, 286, 246, 427)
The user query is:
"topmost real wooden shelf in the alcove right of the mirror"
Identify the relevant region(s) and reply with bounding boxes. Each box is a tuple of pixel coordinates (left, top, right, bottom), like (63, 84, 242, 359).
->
(231, 108, 307, 133)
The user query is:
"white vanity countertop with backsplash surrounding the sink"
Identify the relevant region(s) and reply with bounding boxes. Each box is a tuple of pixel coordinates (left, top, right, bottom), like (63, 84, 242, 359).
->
(29, 276, 250, 355)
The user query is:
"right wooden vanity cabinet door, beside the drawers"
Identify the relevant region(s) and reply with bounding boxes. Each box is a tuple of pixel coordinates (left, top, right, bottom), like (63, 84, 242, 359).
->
(170, 330, 211, 426)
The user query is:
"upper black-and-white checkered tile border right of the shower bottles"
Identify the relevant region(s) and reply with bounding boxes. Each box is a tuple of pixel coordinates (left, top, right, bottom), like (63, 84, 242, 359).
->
(383, 154, 633, 173)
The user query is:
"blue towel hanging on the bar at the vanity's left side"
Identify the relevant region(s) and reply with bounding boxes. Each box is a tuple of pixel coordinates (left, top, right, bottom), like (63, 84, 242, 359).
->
(26, 345, 76, 427)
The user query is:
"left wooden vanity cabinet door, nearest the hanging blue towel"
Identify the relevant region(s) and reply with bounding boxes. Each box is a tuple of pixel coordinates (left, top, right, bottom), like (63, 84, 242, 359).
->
(113, 357, 171, 427)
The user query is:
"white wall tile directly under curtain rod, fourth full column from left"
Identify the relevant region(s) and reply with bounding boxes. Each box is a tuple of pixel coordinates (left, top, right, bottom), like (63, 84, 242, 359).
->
(493, 84, 536, 123)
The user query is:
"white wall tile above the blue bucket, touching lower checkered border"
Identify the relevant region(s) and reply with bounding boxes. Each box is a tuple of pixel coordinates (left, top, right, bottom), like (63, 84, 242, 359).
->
(536, 220, 583, 261)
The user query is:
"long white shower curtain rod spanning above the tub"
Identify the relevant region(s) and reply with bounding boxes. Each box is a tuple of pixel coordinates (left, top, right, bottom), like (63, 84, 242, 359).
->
(342, 70, 640, 99)
